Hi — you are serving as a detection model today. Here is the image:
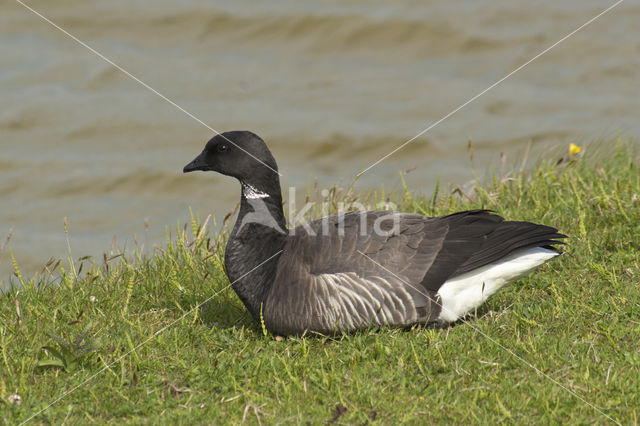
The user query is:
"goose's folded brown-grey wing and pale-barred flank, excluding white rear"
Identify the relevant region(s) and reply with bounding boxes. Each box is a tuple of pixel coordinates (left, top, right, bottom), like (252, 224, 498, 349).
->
(265, 210, 564, 334)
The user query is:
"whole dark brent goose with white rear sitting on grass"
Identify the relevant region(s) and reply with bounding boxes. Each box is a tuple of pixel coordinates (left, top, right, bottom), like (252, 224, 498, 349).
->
(183, 131, 566, 335)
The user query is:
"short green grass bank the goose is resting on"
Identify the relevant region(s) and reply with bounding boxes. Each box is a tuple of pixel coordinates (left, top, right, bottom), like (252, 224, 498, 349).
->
(0, 141, 640, 424)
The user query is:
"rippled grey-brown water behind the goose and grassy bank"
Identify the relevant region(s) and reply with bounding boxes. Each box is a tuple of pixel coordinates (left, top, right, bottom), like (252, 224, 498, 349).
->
(0, 0, 640, 281)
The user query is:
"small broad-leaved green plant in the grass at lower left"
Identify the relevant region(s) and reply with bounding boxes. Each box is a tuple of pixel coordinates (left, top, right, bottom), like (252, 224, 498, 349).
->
(37, 324, 95, 372)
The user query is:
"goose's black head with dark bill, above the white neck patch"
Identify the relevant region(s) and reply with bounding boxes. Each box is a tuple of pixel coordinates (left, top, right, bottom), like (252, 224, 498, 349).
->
(183, 130, 278, 183)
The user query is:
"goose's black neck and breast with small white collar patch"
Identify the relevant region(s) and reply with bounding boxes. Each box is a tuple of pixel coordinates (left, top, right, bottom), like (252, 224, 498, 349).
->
(225, 180, 287, 321)
